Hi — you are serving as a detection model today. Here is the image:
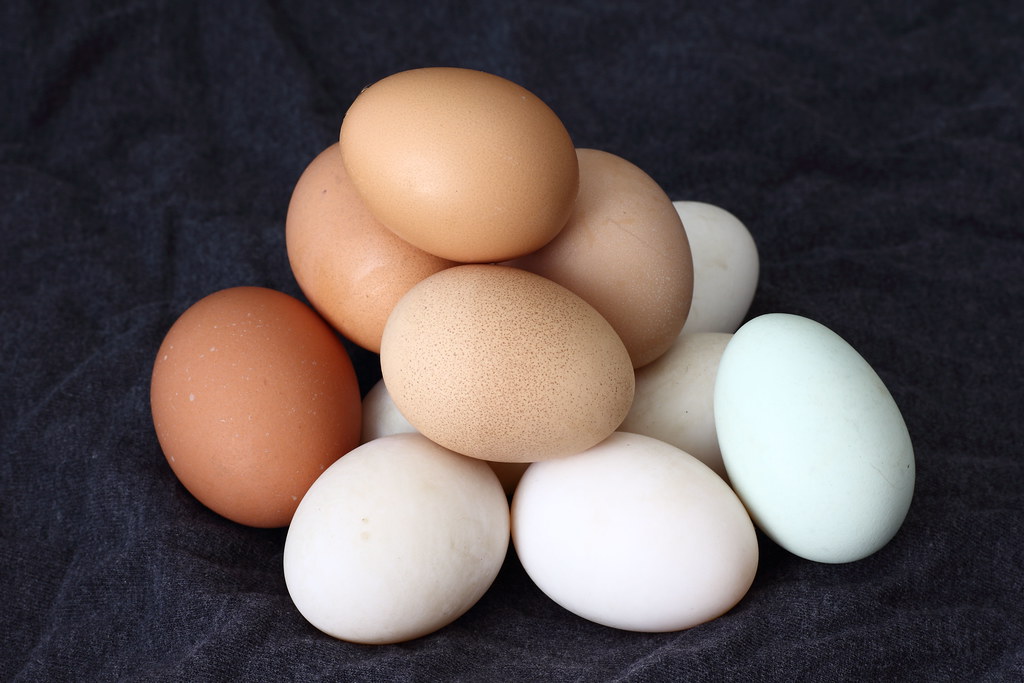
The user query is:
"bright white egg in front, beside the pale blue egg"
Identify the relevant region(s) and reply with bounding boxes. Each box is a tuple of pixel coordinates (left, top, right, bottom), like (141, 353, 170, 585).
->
(512, 432, 758, 632)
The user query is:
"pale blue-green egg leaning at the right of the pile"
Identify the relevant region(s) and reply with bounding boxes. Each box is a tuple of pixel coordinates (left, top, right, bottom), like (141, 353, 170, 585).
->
(714, 313, 914, 563)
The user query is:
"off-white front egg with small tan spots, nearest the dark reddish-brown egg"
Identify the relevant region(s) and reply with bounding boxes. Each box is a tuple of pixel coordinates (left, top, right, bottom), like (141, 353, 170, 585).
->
(284, 434, 509, 644)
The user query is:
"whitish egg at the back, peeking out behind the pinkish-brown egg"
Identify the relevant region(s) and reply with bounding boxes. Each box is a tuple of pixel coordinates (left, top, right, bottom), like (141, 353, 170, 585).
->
(672, 201, 761, 334)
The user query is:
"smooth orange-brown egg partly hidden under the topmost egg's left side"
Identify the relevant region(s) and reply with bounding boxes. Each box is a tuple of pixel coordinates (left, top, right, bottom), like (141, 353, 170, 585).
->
(285, 142, 454, 353)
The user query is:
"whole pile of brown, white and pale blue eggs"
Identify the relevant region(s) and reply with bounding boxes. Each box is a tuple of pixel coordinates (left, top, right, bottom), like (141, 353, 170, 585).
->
(151, 68, 914, 643)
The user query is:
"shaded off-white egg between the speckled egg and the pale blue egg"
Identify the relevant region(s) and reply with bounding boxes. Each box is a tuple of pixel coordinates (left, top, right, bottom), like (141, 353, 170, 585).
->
(618, 332, 732, 478)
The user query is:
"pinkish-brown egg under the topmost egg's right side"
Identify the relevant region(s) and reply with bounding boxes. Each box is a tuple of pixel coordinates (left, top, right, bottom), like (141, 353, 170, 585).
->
(509, 150, 693, 368)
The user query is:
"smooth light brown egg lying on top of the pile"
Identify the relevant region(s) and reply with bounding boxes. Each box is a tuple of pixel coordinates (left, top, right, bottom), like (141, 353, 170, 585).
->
(340, 68, 579, 263)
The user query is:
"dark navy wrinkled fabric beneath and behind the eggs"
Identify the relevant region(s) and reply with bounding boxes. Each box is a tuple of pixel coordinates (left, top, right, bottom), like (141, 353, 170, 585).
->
(0, 0, 1024, 681)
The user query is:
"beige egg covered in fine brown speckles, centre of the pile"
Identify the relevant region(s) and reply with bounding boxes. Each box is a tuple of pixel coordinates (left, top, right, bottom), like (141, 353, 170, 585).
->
(381, 265, 635, 462)
